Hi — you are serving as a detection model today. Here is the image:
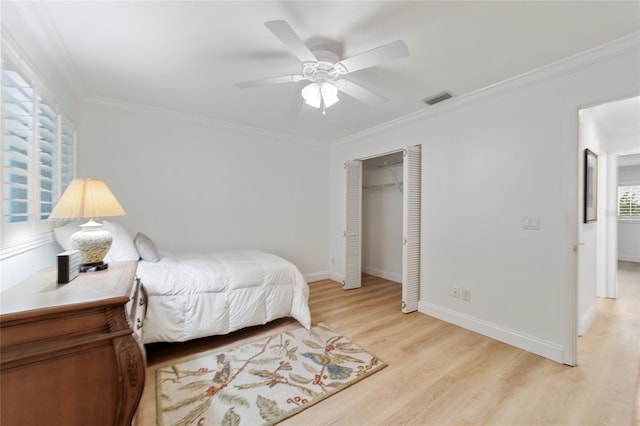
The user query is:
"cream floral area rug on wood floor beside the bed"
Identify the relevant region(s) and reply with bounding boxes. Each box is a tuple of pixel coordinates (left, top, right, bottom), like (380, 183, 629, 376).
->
(156, 323, 386, 426)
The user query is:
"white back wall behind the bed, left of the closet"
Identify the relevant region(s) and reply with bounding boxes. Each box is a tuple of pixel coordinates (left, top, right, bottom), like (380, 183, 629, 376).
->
(78, 102, 329, 280)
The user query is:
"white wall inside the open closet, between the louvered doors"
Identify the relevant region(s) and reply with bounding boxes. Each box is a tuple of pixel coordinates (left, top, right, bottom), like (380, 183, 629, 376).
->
(362, 161, 402, 282)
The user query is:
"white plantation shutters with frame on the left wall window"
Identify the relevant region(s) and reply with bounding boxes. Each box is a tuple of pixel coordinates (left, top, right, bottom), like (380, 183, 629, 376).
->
(0, 45, 75, 243)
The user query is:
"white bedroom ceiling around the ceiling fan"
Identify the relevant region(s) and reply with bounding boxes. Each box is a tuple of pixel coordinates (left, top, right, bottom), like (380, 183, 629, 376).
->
(3, 1, 640, 143)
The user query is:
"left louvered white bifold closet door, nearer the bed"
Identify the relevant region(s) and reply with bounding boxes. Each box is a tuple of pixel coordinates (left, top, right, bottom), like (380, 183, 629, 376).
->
(343, 161, 362, 290)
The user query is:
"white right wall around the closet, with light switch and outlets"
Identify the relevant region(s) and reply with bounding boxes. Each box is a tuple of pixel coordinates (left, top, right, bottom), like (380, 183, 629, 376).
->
(330, 38, 640, 363)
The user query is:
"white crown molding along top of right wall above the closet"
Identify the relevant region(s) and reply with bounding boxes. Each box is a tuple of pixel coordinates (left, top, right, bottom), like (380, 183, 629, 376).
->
(329, 32, 640, 148)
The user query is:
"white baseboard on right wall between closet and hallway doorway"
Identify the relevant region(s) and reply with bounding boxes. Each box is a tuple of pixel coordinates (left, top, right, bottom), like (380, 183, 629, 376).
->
(418, 301, 563, 363)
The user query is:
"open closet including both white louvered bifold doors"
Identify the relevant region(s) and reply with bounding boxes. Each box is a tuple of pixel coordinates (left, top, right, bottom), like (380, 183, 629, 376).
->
(343, 145, 422, 313)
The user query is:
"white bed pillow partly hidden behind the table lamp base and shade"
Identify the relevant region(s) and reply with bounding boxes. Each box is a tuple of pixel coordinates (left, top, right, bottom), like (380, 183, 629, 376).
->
(53, 220, 140, 262)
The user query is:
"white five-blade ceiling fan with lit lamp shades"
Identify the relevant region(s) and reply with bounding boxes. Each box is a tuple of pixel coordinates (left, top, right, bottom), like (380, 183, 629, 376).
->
(236, 21, 409, 115)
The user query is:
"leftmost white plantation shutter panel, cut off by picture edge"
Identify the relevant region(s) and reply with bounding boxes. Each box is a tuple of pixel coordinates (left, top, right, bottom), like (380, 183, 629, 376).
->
(2, 63, 34, 223)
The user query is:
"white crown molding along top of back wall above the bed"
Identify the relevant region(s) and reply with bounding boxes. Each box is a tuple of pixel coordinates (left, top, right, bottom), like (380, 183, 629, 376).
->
(83, 95, 329, 149)
